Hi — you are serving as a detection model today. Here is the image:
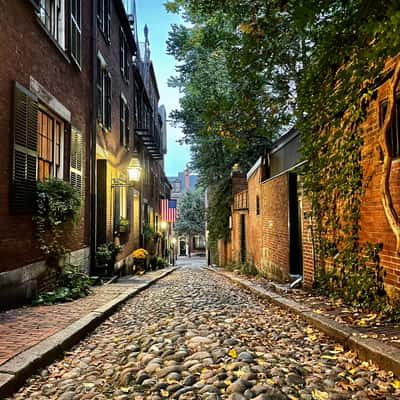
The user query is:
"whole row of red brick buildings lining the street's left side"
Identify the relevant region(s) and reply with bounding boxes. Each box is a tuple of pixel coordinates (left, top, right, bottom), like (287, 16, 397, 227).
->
(0, 0, 170, 307)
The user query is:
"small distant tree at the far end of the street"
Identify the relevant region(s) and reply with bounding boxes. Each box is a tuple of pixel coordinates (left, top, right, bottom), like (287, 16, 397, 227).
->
(174, 189, 205, 256)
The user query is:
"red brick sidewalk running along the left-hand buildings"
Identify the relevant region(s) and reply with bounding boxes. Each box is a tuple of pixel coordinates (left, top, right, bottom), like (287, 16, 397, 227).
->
(0, 271, 170, 366)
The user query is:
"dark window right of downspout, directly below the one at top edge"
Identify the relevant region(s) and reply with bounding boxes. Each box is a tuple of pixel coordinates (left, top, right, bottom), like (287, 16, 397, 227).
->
(96, 57, 111, 130)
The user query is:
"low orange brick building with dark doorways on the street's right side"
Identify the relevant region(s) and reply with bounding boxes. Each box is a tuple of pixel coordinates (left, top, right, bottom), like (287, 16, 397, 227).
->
(219, 130, 313, 282)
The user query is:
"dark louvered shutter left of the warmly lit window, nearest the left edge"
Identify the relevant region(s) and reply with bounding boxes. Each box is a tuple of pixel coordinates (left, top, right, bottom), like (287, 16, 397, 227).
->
(10, 82, 38, 214)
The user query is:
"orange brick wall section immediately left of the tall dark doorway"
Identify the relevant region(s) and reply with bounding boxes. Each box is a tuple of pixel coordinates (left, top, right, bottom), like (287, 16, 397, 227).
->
(261, 174, 289, 281)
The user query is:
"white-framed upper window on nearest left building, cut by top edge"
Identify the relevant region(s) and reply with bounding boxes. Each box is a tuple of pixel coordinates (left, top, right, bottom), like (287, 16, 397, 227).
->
(38, 0, 65, 49)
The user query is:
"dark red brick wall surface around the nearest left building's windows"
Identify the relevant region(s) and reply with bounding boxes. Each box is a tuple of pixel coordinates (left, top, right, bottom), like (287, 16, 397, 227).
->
(0, 0, 91, 272)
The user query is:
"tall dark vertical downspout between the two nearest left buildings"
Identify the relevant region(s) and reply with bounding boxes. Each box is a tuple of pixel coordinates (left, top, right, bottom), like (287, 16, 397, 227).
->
(89, 1, 97, 273)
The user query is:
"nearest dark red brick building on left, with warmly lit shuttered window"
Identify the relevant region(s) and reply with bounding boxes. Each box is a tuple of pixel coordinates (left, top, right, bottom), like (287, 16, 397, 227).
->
(0, 0, 93, 307)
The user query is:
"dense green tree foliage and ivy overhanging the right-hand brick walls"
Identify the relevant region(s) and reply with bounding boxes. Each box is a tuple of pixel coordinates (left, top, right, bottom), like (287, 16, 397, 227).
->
(166, 0, 400, 310)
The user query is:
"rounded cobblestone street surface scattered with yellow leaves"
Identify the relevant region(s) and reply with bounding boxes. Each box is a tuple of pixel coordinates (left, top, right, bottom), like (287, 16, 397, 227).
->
(13, 265, 400, 400)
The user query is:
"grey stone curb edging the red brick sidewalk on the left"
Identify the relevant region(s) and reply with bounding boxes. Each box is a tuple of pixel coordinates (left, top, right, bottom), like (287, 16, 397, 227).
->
(0, 267, 176, 399)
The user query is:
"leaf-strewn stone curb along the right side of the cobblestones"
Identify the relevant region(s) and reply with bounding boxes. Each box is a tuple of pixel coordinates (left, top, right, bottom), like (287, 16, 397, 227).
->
(206, 267, 400, 376)
